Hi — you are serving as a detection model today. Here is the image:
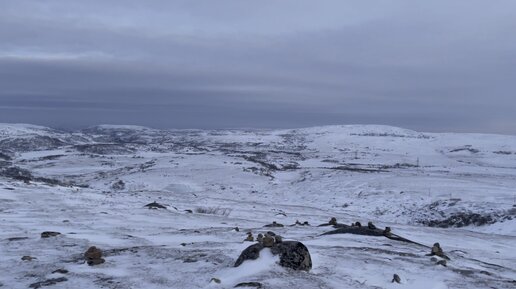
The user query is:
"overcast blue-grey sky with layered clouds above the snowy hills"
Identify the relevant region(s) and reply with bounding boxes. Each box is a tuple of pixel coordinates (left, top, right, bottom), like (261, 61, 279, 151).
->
(0, 0, 516, 134)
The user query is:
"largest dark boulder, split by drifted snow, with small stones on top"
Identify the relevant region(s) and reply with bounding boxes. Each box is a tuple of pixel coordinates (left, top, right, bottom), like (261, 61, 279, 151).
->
(235, 241, 312, 271)
